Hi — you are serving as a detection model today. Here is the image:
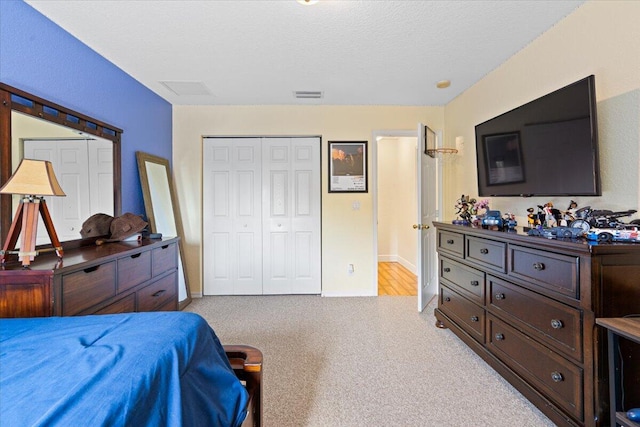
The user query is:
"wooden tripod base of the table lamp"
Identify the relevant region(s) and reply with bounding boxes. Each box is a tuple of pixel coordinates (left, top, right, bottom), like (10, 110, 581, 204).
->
(0, 196, 64, 267)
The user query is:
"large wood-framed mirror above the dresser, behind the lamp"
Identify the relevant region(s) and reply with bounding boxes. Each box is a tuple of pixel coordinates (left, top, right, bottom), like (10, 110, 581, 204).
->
(0, 83, 122, 248)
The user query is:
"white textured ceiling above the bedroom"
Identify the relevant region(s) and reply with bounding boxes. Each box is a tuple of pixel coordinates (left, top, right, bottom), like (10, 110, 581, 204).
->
(26, 0, 583, 105)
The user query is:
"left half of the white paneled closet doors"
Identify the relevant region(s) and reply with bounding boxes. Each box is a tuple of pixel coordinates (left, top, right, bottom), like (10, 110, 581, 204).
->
(202, 138, 262, 295)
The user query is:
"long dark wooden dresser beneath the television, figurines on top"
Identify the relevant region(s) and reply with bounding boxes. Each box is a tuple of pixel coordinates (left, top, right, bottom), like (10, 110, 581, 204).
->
(434, 223, 640, 426)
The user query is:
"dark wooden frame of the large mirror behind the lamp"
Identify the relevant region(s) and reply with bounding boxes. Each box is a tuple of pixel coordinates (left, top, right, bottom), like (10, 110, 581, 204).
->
(0, 83, 123, 248)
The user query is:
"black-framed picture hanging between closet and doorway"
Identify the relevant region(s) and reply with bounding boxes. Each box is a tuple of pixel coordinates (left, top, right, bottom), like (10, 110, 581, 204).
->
(329, 141, 368, 193)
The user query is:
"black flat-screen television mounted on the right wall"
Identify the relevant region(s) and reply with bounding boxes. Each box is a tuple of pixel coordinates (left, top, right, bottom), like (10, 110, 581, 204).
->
(475, 76, 602, 197)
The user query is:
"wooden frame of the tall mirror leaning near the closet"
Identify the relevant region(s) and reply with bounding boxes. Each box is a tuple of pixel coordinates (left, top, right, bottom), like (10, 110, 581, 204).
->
(136, 151, 191, 310)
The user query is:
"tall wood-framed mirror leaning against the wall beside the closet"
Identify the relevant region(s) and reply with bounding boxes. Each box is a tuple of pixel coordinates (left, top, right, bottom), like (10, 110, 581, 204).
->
(136, 151, 191, 310)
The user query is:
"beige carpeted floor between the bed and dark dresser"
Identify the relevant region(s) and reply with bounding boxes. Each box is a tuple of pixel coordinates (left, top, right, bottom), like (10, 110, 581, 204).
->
(186, 295, 554, 427)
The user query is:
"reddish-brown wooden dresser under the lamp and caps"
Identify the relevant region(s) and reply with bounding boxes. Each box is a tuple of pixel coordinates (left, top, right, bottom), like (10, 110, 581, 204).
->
(0, 238, 178, 317)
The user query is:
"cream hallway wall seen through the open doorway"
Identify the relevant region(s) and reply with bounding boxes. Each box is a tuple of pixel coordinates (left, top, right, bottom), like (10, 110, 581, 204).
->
(378, 137, 418, 273)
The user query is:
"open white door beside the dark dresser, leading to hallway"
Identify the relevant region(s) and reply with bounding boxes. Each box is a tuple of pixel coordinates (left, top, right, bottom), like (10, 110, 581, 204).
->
(414, 123, 438, 312)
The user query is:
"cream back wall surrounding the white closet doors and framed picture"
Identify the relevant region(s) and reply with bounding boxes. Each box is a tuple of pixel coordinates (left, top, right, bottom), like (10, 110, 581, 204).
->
(173, 105, 444, 296)
